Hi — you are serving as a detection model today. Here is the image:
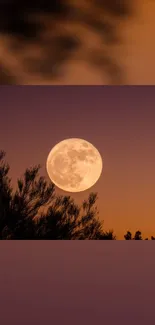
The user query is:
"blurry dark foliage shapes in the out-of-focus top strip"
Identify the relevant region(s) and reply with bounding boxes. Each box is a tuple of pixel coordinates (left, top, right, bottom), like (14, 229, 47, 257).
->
(0, 0, 132, 84)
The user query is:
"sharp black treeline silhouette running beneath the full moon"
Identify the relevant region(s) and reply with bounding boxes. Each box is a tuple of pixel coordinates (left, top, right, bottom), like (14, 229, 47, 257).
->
(0, 150, 155, 240)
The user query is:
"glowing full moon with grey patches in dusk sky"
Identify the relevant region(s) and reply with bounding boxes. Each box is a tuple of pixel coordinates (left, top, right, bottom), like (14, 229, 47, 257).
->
(46, 138, 103, 192)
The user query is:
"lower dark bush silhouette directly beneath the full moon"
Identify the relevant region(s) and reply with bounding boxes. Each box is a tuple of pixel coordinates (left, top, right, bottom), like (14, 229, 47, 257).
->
(36, 193, 109, 239)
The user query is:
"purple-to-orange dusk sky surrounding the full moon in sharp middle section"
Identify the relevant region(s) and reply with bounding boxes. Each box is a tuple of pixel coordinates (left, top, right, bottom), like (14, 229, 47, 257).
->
(0, 86, 155, 239)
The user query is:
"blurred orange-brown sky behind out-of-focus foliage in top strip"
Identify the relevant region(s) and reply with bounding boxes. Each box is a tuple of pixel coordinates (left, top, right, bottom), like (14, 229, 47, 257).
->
(0, 0, 155, 85)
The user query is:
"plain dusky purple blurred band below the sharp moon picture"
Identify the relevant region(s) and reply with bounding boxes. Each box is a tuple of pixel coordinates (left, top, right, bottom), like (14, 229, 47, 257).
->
(0, 241, 155, 325)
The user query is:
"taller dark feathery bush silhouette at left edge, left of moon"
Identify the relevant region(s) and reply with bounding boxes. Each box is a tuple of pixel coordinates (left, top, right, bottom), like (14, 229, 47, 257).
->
(0, 151, 54, 239)
